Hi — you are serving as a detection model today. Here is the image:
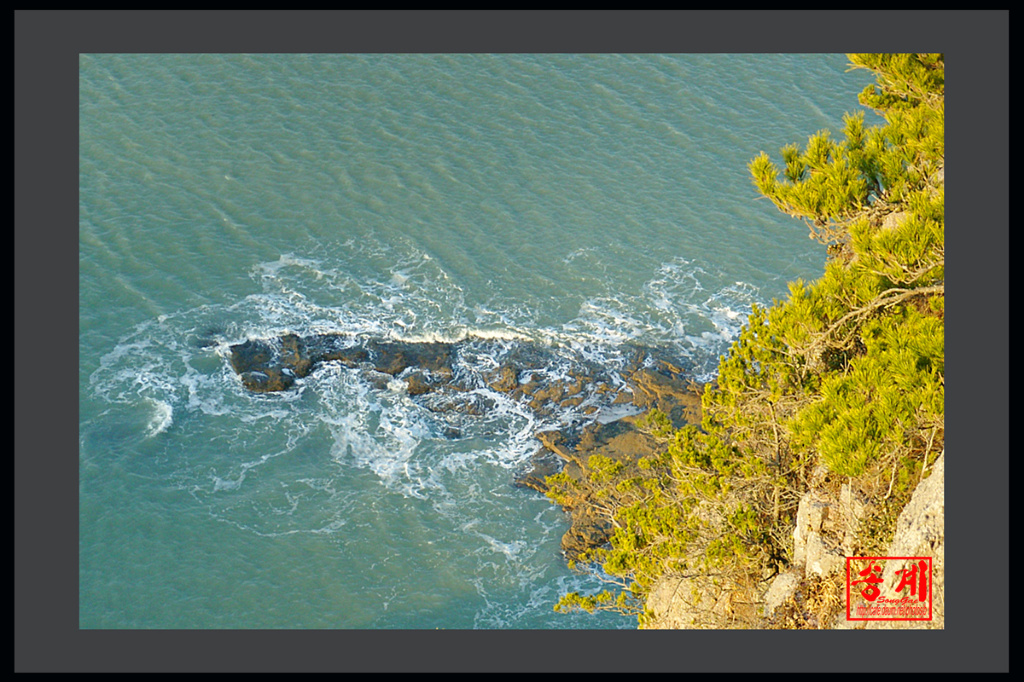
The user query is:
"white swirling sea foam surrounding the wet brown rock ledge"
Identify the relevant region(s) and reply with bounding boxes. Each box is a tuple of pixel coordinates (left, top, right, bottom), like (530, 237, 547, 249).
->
(91, 247, 770, 524)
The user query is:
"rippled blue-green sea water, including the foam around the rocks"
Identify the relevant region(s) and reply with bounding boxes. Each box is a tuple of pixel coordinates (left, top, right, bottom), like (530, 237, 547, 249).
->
(79, 54, 870, 629)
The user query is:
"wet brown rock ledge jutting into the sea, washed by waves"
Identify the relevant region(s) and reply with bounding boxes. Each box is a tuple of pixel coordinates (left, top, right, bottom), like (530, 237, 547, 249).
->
(229, 334, 700, 558)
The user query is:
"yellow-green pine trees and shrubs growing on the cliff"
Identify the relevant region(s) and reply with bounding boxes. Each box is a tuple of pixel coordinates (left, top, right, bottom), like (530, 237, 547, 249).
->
(549, 54, 945, 627)
